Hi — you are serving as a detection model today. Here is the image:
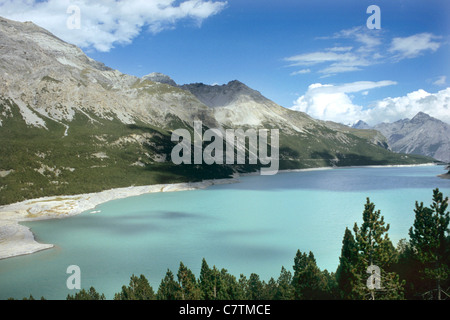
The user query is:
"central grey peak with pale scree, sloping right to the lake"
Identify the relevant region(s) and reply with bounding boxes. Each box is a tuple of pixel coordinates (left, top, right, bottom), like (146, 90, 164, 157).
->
(181, 80, 429, 168)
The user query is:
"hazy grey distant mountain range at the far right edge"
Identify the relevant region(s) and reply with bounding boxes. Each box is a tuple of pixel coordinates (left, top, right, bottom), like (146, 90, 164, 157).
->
(353, 112, 450, 163)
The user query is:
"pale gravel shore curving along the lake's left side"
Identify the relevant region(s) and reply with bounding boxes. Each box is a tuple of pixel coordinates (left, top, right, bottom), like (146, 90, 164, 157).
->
(0, 178, 238, 260)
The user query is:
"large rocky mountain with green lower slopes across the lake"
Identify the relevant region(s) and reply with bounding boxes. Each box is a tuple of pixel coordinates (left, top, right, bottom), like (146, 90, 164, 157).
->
(0, 18, 430, 204)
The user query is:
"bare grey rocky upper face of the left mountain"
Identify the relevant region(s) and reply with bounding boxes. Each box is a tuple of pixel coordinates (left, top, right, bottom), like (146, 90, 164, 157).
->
(0, 19, 215, 130)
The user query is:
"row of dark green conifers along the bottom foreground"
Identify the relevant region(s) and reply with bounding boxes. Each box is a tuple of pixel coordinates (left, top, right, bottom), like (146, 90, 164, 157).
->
(8, 189, 450, 300)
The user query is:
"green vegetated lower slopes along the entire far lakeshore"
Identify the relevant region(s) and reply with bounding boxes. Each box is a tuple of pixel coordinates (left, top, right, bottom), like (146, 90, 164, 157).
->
(0, 101, 430, 204)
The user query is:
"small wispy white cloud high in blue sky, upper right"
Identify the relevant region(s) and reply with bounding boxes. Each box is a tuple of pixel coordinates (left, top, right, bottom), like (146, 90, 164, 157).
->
(389, 33, 441, 59)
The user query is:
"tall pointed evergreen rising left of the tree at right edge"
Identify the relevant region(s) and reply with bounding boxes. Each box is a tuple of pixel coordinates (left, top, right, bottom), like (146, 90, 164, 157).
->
(352, 198, 404, 300)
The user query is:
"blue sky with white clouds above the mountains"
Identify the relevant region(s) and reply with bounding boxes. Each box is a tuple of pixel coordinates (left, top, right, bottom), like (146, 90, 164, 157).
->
(0, 0, 450, 125)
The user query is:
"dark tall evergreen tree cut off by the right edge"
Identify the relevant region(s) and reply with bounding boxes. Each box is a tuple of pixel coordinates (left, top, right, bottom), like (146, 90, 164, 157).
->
(409, 189, 450, 300)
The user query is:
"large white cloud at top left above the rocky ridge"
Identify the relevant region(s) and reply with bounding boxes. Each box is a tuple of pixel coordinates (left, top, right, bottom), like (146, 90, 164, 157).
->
(0, 0, 227, 51)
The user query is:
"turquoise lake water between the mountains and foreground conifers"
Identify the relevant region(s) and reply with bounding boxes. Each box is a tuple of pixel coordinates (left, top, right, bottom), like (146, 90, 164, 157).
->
(0, 166, 450, 299)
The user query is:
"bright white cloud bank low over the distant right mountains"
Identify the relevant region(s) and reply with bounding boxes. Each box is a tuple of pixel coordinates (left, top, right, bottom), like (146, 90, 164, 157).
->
(292, 80, 450, 125)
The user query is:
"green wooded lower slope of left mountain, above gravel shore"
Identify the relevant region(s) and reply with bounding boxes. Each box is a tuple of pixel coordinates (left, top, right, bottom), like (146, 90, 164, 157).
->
(0, 100, 233, 205)
